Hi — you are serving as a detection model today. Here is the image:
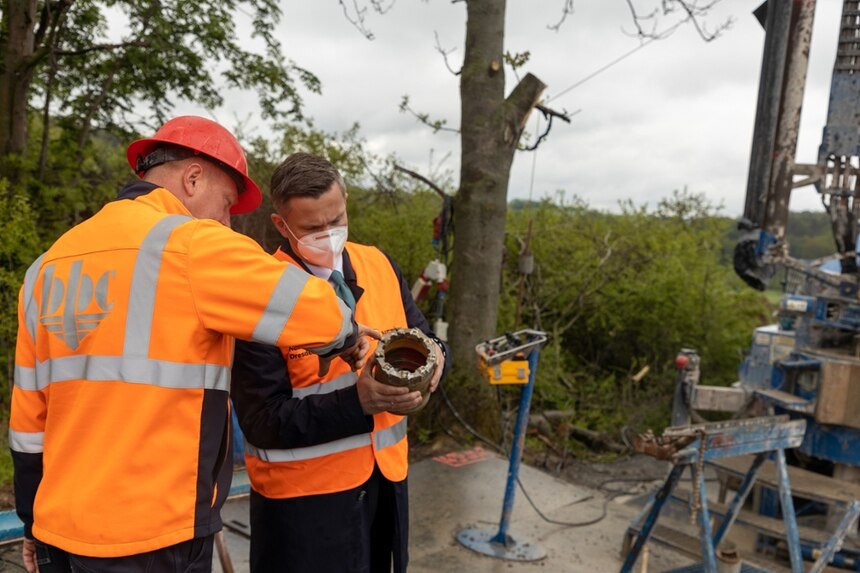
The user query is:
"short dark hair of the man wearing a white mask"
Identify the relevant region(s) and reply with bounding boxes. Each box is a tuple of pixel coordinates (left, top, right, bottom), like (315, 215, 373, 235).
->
(271, 152, 346, 209)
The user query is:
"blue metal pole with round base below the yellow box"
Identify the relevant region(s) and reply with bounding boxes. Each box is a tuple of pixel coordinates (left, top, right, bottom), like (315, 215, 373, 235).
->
(457, 348, 546, 561)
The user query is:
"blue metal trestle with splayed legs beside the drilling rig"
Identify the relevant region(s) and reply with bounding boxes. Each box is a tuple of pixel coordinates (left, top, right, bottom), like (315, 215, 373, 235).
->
(620, 416, 860, 573)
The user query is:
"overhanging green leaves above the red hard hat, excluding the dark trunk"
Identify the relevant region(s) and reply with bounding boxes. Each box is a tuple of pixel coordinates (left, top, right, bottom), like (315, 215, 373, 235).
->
(24, 0, 319, 131)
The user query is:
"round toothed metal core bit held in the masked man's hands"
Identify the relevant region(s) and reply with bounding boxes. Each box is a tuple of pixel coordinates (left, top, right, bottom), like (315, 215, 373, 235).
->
(373, 328, 436, 414)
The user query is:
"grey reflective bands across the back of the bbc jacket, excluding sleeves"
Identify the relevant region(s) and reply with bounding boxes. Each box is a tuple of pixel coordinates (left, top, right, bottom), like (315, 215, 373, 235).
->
(15, 215, 239, 391)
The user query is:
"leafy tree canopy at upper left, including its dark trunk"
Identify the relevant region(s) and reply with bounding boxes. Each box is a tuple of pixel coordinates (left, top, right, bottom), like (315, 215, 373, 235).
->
(0, 0, 319, 160)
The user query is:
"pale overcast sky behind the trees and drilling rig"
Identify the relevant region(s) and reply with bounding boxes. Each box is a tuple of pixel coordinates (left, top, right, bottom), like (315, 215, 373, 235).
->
(186, 0, 842, 216)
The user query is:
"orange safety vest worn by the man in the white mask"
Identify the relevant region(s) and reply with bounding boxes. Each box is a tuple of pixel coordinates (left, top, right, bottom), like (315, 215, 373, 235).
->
(245, 243, 409, 498)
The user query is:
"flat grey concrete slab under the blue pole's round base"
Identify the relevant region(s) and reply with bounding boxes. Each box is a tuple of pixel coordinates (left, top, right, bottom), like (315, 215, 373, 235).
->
(213, 446, 690, 573)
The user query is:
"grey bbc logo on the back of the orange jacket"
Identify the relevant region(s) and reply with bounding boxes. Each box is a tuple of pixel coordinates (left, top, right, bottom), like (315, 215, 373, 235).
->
(39, 261, 116, 350)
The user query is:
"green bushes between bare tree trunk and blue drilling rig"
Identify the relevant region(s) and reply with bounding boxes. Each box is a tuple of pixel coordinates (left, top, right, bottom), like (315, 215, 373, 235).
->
(500, 193, 767, 430)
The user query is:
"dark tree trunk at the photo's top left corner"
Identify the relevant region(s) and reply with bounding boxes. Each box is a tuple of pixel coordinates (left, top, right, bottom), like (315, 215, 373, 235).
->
(0, 0, 36, 158)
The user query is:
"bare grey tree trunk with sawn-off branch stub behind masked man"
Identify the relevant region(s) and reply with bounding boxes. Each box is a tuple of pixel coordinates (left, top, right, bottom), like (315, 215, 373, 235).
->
(450, 0, 546, 366)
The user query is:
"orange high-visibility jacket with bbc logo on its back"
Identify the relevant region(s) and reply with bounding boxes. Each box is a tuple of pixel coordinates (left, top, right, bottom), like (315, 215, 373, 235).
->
(9, 189, 355, 557)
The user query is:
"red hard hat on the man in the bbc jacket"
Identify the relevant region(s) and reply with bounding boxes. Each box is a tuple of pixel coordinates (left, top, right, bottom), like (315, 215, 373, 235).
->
(125, 115, 263, 215)
